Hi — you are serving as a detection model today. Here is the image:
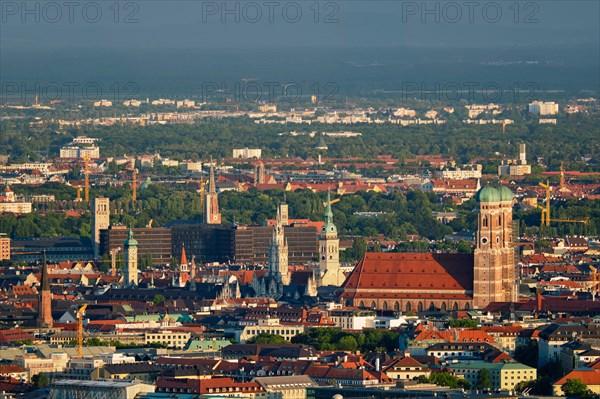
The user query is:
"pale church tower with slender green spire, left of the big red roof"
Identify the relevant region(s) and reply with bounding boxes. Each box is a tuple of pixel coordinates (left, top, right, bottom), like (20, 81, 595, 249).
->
(319, 192, 343, 287)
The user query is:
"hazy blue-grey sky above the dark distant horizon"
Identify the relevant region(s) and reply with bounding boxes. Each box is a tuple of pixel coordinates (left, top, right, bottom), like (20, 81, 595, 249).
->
(0, 0, 600, 50)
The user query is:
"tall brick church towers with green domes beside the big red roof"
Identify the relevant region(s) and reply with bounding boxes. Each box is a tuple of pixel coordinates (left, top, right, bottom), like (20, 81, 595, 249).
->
(473, 187, 517, 309)
